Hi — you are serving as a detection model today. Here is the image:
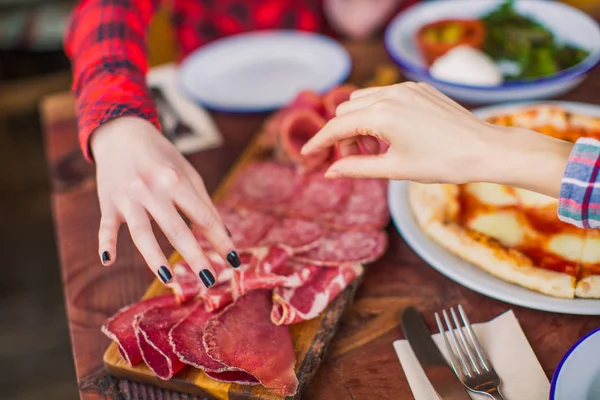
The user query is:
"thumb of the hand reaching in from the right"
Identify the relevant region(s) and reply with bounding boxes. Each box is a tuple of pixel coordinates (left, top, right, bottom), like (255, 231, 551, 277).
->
(325, 154, 397, 179)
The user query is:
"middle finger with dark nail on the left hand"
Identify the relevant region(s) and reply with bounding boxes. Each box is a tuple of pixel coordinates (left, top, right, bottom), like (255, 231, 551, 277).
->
(146, 197, 215, 287)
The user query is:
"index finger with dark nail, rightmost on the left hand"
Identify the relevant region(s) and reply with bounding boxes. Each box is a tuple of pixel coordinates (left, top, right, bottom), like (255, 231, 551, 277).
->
(173, 181, 240, 268)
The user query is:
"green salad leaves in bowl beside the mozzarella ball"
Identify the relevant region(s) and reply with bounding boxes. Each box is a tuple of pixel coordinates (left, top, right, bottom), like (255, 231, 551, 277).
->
(481, 0, 589, 80)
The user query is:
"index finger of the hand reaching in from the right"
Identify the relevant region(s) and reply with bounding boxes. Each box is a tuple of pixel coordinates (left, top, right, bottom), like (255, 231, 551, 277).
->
(301, 110, 382, 155)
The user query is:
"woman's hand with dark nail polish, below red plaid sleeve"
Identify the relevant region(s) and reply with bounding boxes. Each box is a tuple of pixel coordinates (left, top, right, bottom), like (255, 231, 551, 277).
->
(91, 117, 239, 287)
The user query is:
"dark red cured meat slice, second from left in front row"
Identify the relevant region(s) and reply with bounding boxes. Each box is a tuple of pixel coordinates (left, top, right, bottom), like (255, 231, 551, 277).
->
(134, 301, 199, 380)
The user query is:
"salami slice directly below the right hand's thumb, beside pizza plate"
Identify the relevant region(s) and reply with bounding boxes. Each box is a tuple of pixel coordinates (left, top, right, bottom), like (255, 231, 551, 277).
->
(325, 179, 390, 230)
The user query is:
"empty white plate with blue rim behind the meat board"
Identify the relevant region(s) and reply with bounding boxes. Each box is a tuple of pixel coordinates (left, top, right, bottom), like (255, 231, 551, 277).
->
(179, 31, 352, 112)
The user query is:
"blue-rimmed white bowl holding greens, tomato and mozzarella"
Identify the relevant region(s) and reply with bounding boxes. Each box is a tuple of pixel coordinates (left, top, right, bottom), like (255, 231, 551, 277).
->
(385, 0, 600, 103)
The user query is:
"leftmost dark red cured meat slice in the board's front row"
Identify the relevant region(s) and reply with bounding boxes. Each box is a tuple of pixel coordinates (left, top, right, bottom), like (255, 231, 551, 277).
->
(102, 294, 177, 366)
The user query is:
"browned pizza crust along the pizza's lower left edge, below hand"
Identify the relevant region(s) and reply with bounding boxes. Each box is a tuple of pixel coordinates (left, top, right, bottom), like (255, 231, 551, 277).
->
(409, 182, 575, 299)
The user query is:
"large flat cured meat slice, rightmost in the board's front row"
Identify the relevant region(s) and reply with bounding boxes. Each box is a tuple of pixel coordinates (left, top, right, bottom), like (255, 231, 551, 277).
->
(204, 290, 298, 396)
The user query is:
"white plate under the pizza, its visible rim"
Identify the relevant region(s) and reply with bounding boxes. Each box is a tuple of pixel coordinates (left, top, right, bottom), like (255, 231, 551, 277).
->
(388, 102, 600, 315)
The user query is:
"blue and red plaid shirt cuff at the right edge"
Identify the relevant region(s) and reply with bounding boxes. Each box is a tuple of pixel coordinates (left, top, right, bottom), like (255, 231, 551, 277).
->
(558, 138, 600, 228)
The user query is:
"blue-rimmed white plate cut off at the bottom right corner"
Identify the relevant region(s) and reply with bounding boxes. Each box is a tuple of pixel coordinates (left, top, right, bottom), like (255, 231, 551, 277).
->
(550, 328, 600, 400)
